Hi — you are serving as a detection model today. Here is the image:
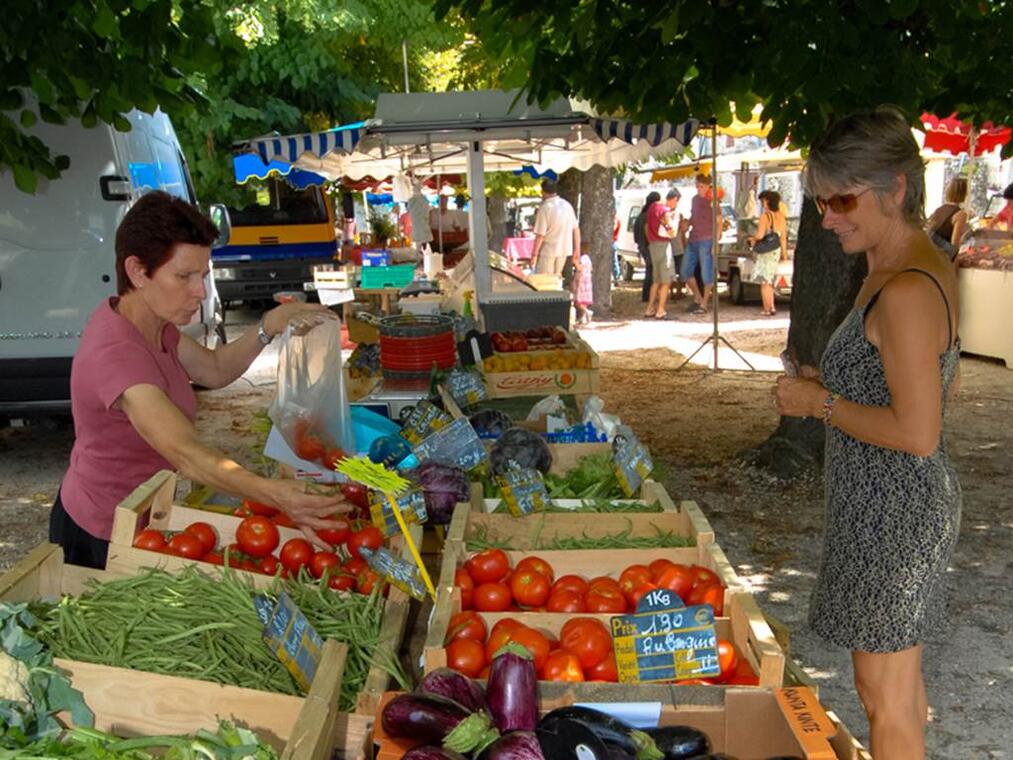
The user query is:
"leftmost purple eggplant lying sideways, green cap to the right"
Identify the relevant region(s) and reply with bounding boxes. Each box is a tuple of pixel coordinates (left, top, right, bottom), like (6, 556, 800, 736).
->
(380, 694, 498, 753)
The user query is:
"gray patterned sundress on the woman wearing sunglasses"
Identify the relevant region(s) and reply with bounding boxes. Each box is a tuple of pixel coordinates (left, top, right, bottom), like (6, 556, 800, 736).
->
(809, 270, 961, 653)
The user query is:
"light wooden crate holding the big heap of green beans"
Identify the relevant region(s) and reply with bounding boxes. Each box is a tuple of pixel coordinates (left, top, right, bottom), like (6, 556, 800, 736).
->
(0, 544, 368, 760)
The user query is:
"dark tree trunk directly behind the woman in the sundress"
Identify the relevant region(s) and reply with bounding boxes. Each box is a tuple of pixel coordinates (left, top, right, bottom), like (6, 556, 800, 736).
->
(747, 198, 868, 478)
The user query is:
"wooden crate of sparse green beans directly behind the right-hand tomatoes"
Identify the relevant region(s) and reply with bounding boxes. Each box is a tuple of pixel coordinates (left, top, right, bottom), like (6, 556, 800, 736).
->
(447, 480, 714, 551)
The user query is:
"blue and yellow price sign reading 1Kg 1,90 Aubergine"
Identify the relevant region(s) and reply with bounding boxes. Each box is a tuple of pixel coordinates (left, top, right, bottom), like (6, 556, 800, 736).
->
(611, 589, 721, 683)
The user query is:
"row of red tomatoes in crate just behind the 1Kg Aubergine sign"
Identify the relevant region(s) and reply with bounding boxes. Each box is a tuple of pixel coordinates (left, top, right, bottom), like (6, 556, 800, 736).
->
(454, 549, 724, 617)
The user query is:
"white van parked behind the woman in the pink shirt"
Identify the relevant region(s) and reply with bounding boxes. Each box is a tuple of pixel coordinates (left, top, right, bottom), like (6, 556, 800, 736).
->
(0, 104, 221, 415)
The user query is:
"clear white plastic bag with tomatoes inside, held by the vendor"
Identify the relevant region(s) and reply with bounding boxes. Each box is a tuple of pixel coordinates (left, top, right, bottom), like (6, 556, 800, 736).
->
(268, 319, 356, 469)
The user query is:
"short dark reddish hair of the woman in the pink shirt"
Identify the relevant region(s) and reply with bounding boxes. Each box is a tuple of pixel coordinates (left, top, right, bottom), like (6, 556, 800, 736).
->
(115, 191, 218, 296)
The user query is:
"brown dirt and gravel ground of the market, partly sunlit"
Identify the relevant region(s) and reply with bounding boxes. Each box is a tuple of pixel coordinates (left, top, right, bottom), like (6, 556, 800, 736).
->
(0, 283, 1013, 760)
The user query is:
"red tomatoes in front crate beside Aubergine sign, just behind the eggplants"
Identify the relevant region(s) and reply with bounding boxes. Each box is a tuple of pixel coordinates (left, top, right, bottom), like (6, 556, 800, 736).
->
(444, 610, 759, 686)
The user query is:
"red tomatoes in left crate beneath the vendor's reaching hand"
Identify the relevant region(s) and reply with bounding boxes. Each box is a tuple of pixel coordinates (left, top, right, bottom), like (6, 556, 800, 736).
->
(134, 515, 383, 594)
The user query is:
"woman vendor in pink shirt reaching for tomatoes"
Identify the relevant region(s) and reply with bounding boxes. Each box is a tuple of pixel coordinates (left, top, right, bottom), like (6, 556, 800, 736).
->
(50, 192, 350, 567)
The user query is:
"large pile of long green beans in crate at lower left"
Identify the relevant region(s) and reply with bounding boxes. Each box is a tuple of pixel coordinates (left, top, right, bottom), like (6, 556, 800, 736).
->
(34, 566, 406, 709)
